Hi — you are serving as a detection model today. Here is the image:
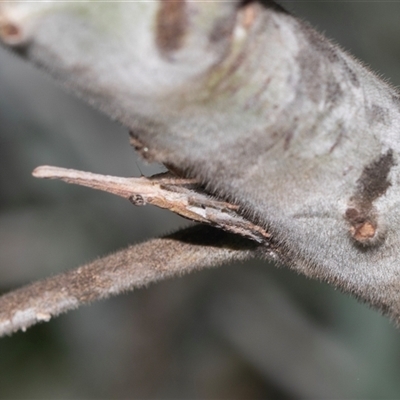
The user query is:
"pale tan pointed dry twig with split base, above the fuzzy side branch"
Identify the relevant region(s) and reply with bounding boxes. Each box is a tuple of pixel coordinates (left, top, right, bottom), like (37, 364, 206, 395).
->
(33, 166, 270, 243)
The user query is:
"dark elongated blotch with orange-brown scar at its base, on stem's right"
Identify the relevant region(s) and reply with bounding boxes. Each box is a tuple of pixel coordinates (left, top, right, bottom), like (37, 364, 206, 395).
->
(345, 150, 395, 246)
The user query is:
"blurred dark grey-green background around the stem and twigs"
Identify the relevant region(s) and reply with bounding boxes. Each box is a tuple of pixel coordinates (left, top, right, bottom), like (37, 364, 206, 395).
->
(0, 1, 400, 399)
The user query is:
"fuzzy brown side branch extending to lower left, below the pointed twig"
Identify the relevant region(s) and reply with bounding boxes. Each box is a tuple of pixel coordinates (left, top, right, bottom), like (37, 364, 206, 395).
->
(0, 225, 257, 336)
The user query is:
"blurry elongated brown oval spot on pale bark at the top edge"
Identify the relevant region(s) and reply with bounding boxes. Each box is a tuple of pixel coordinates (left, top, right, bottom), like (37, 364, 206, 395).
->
(156, 0, 188, 56)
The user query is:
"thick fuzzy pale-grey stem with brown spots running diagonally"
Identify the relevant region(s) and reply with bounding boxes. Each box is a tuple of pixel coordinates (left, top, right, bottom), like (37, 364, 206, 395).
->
(0, 1, 400, 334)
